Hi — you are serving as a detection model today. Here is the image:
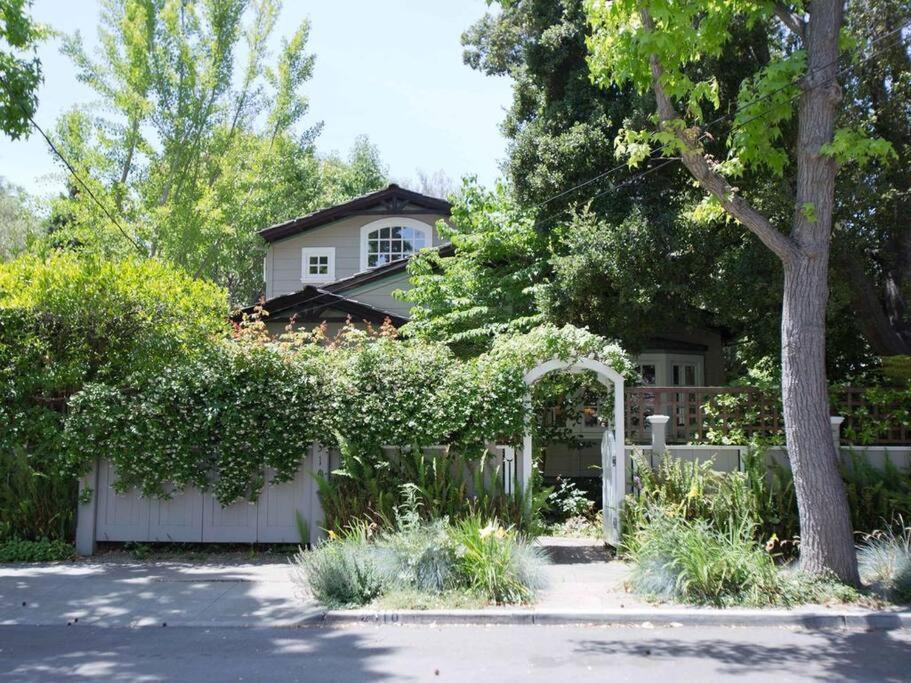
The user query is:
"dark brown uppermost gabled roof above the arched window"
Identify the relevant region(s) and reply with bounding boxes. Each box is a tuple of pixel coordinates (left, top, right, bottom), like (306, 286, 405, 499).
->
(259, 183, 452, 242)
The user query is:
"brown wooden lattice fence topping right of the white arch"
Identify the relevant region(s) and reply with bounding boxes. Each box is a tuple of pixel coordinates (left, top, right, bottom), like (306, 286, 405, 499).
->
(625, 387, 911, 445)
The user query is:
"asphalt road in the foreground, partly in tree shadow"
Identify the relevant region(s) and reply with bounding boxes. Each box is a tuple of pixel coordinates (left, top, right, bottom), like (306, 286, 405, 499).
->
(0, 624, 911, 683)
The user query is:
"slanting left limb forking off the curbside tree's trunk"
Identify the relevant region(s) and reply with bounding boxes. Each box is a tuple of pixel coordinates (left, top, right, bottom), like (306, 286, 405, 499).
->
(641, 8, 798, 262)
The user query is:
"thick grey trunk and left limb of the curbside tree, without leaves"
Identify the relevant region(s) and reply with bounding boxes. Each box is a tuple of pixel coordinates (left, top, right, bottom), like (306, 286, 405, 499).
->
(641, 0, 860, 585)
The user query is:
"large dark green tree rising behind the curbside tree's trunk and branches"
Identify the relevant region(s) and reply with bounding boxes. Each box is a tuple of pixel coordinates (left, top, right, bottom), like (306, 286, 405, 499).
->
(463, 0, 896, 380)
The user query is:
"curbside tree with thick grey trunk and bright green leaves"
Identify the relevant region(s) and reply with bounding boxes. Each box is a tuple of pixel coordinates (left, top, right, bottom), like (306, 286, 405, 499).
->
(587, 0, 900, 584)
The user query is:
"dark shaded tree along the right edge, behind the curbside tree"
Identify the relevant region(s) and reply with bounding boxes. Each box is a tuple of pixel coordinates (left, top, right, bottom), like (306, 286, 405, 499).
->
(834, 0, 911, 356)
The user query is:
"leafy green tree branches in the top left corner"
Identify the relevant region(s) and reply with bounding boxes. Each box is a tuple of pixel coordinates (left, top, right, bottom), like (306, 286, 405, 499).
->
(0, 0, 45, 140)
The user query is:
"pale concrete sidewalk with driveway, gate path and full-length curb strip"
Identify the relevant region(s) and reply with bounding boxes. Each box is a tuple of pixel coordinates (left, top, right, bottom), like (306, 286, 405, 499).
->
(0, 539, 911, 628)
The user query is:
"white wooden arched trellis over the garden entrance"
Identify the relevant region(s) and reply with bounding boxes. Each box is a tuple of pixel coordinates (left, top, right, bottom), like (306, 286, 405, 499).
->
(516, 357, 626, 546)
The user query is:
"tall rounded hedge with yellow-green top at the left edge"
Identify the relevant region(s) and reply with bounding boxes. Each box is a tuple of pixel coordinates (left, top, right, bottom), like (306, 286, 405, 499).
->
(0, 254, 226, 539)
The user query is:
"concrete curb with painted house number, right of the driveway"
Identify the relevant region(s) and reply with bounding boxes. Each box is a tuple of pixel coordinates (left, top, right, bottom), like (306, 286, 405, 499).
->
(318, 609, 911, 631)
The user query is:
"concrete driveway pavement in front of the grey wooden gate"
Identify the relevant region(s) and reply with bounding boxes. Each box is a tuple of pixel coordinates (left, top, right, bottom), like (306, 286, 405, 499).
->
(0, 561, 323, 626)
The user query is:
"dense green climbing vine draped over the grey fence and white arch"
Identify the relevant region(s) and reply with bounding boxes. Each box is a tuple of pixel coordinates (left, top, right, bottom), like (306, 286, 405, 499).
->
(63, 326, 632, 505)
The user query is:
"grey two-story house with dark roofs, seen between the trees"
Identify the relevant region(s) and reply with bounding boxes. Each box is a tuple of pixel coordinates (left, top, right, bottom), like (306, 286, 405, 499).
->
(248, 185, 724, 387)
